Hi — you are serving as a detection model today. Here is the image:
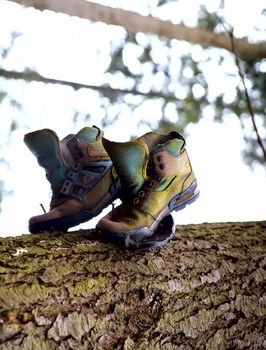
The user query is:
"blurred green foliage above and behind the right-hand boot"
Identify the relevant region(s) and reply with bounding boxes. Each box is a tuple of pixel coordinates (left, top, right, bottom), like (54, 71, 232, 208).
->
(101, 0, 266, 165)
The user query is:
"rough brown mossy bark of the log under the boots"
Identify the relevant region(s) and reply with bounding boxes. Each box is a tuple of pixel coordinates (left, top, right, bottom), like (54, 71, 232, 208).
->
(0, 222, 266, 350)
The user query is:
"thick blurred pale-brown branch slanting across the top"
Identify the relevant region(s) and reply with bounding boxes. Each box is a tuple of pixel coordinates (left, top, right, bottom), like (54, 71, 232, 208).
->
(7, 0, 266, 61)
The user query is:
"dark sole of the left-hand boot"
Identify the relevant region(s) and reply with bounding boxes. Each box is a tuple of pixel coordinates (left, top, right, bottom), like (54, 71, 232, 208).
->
(29, 183, 118, 233)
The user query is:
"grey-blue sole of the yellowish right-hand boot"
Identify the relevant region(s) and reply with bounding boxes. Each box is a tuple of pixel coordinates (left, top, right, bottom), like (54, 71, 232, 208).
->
(98, 181, 200, 246)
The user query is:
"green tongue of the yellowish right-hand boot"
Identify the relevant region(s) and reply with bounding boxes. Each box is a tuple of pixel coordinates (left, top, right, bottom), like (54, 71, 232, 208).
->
(102, 138, 149, 197)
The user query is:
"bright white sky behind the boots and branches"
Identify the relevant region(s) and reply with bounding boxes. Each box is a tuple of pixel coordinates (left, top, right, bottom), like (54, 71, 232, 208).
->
(0, 0, 266, 236)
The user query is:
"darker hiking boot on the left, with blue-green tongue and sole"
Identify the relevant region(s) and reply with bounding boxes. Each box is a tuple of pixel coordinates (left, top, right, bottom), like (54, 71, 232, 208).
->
(24, 126, 119, 233)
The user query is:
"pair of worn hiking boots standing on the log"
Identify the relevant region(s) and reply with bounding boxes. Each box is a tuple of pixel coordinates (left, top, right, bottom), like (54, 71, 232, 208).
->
(24, 126, 199, 248)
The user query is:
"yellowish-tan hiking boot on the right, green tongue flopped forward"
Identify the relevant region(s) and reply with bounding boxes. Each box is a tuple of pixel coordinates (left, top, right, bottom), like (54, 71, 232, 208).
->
(97, 132, 199, 244)
